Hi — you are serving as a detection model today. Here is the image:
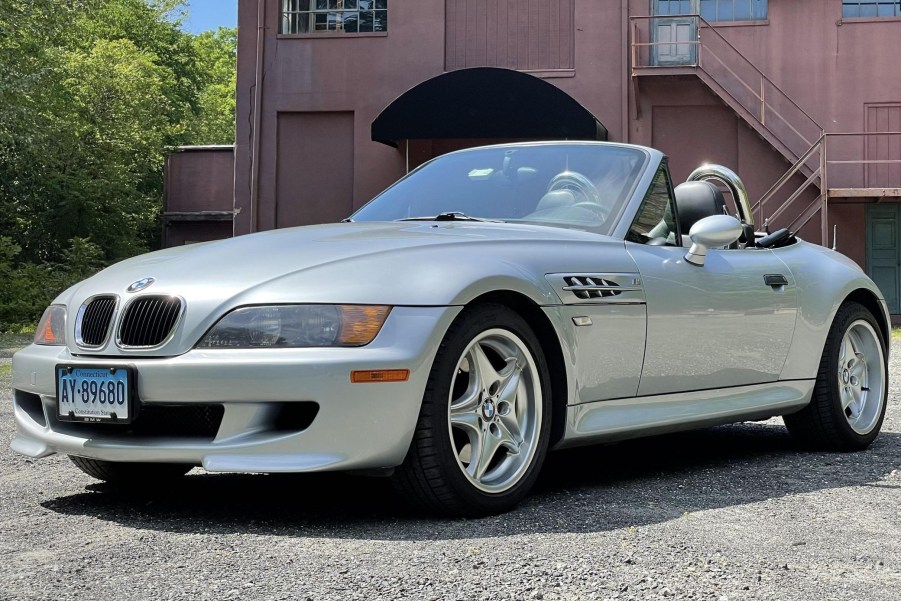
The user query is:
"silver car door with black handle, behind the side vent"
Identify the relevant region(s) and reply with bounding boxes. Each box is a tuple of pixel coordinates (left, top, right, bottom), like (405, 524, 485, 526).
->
(626, 242, 798, 396)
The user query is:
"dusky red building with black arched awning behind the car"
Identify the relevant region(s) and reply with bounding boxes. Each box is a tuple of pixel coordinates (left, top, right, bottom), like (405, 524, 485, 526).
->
(167, 0, 901, 314)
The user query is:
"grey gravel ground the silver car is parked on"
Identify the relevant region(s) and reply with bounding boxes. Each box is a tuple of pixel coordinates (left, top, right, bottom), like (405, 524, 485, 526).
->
(0, 340, 901, 601)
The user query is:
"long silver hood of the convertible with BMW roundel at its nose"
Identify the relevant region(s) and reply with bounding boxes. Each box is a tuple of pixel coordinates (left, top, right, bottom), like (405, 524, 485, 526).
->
(57, 221, 632, 351)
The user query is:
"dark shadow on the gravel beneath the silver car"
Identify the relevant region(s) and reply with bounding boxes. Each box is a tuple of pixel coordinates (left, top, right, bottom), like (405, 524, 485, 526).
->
(41, 423, 901, 540)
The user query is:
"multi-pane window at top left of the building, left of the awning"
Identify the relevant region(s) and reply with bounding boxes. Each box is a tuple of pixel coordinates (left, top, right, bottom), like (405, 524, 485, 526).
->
(278, 0, 388, 34)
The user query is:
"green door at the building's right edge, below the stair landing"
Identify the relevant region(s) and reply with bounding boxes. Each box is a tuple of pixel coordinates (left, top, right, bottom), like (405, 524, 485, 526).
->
(867, 205, 901, 314)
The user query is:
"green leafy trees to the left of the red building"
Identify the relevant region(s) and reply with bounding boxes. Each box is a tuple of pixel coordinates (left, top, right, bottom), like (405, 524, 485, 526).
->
(0, 0, 236, 331)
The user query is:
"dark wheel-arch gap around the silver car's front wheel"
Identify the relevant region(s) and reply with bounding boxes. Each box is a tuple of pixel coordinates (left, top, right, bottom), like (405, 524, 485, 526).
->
(466, 290, 569, 448)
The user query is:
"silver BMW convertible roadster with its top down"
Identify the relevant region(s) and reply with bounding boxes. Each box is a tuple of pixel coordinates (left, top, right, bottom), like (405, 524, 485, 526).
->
(12, 142, 890, 515)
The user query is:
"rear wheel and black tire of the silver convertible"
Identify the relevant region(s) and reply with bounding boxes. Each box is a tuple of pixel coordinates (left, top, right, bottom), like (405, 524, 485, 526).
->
(783, 302, 888, 451)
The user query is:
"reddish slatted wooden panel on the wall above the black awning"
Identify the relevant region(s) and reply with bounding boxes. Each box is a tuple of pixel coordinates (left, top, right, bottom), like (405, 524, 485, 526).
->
(445, 0, 574, 71)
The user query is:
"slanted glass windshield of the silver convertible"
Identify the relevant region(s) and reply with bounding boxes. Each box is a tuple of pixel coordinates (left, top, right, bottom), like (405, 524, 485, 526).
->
(351, 144, 648, 234)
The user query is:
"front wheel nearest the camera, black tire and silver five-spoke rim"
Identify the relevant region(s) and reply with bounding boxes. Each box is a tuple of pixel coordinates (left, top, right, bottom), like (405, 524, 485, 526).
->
(393, 304, 551, 517)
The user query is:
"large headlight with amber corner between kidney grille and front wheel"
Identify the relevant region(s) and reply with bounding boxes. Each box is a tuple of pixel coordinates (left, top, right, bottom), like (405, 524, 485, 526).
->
(197, 305, 391, 348)
